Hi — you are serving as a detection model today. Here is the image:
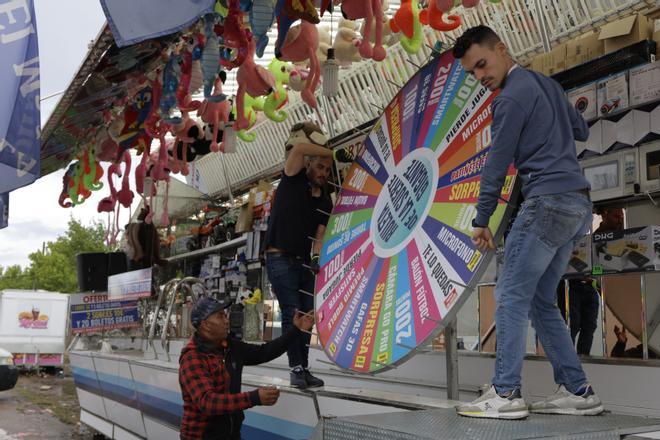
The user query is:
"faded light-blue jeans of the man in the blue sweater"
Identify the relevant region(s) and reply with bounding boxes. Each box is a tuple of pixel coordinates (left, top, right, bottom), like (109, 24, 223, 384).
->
(493, 192, 592, 393)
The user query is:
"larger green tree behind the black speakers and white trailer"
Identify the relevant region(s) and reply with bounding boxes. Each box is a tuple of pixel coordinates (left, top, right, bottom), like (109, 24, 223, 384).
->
(26, 218, 109, 293)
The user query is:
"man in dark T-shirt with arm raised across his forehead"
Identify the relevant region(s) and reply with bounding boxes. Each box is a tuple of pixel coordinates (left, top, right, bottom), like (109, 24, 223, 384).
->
(266, 122, 353, 388)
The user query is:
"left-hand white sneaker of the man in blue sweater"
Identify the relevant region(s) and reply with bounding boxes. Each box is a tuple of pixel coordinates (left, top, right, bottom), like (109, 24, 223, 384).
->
(456, 386, 529, 420)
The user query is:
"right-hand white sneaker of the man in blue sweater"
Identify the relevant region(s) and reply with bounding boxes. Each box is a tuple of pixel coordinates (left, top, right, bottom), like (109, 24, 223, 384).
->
(529, 385, 605, 416)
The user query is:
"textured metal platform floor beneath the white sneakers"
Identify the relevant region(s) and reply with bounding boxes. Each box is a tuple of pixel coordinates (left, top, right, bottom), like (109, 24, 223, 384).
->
(311, 409, 660, 440)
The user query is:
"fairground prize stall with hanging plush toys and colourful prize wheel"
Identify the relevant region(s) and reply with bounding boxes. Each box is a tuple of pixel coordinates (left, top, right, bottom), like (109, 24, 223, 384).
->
(32, 0, 660, 439)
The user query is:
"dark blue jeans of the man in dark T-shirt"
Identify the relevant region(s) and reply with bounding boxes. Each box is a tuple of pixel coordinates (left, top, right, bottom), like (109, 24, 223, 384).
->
(266, 253, 314, 368)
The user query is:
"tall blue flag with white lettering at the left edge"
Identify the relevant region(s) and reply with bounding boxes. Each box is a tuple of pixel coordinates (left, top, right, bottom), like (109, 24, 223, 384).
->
(0, 0, 41, 199)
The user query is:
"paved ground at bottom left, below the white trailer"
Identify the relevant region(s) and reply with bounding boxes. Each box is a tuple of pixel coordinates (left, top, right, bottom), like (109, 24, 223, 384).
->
(0, 374, 93, 440)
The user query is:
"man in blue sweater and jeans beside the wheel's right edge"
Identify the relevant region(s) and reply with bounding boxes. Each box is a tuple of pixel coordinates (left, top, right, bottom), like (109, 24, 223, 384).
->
(453, 26, 603, 419)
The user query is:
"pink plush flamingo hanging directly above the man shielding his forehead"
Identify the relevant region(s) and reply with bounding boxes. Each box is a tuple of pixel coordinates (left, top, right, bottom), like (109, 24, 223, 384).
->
(277, 21, 321, 108)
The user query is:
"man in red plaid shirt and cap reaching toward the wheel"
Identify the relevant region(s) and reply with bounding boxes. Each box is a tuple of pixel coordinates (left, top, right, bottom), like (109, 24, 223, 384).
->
(179, 297, 314, 440)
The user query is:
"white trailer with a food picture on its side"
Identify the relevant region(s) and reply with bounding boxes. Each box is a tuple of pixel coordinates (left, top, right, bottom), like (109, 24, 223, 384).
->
(0, 290, 69, 367)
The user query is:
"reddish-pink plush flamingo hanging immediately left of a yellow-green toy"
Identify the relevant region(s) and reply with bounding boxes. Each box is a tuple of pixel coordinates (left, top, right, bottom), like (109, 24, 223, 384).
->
(234, 34, 279, 131)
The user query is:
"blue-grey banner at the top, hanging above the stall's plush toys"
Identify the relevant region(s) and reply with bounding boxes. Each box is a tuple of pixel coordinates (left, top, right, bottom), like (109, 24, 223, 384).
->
(101, 0, 215, 47)
